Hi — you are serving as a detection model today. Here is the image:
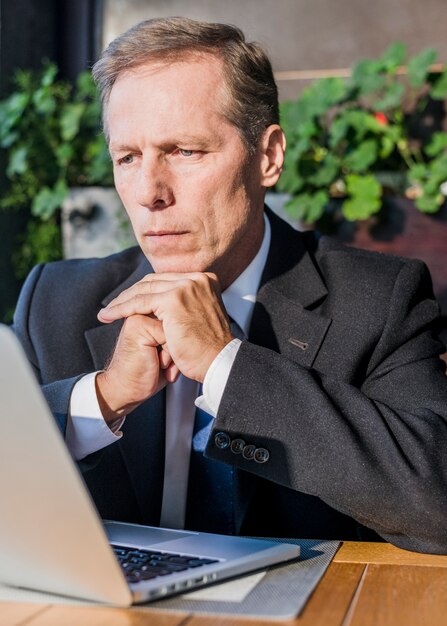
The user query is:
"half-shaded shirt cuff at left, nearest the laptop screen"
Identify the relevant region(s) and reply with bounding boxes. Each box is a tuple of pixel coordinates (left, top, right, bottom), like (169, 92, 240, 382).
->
(65, 372, 125, 461)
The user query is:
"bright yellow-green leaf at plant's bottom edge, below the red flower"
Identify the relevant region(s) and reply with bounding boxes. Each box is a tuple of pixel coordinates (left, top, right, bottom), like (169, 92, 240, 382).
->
(342, 174, 382, 221)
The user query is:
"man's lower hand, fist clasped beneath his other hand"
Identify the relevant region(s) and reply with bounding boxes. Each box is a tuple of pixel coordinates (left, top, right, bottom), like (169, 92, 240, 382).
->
(96, 315, 179, 423)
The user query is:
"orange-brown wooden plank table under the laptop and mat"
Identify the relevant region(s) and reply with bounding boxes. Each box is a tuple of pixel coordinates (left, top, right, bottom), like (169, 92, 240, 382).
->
(0, 542, 447, 626)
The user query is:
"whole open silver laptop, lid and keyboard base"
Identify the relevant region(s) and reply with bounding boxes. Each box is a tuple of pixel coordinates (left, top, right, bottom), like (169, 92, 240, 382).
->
(0, 325, 299, 606)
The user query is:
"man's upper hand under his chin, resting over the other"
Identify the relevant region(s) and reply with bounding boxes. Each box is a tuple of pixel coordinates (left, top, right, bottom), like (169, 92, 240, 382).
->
(98, 272, 233, 382)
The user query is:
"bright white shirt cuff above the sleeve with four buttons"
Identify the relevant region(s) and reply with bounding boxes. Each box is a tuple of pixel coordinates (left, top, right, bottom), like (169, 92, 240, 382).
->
(196, 339, 242, 417)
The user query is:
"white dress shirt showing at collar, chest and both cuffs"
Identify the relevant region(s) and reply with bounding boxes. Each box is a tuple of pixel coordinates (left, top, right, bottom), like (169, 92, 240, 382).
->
(66, 214, 271, 528)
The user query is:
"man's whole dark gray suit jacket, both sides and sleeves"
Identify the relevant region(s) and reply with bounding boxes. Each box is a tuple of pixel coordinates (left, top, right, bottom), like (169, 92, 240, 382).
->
(15, 214, 447, 553)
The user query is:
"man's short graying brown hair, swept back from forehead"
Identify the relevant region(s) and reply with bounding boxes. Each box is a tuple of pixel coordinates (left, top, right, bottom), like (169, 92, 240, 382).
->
(93, 17, 279, 153)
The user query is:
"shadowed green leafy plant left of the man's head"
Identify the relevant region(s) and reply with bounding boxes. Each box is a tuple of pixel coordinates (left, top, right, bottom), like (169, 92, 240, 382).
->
(0, 62, 113, 275)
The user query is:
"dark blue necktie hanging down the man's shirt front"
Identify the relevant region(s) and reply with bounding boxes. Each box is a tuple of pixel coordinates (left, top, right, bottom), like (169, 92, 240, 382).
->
(185, 322, 245, 535)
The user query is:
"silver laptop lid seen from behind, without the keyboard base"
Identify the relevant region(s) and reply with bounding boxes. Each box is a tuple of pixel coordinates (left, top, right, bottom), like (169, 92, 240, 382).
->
(0, 325, 132, 605)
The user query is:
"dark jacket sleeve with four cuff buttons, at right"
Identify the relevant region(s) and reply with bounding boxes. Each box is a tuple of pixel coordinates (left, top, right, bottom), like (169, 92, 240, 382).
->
(206, 261, 447, 553)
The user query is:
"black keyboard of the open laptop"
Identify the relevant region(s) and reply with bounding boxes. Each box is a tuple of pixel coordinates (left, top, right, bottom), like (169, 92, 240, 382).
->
(112, 545, 218, 583)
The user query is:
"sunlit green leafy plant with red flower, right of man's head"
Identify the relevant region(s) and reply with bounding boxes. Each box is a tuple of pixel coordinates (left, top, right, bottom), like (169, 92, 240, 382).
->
(277, 43, 447, 229)
